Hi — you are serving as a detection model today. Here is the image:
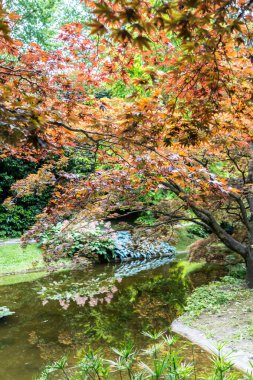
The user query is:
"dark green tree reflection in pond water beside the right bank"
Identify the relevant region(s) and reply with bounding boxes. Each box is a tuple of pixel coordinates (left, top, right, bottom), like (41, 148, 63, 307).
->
(78, 265, 188, 345)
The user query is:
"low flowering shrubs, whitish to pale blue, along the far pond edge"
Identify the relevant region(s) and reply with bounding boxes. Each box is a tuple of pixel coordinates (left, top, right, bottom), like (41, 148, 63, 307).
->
(41, 221, 175, 261)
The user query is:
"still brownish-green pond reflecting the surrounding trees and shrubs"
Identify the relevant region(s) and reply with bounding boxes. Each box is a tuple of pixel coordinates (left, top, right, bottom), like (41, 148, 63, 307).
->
(0, 258, 224, 380)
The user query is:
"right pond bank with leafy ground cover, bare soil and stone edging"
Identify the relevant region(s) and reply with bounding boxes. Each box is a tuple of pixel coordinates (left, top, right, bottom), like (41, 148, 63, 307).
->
(171, 277, 253, 374)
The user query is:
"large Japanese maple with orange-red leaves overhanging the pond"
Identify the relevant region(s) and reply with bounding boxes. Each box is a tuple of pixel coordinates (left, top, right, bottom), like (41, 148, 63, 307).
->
(0, 0, 253, 287)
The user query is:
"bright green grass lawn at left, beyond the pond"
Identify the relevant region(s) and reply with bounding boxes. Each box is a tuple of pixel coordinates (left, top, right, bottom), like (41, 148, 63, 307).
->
(0, 244, 44, 275)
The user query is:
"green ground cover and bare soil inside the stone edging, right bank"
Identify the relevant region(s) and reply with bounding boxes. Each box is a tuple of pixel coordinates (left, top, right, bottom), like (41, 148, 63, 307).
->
(179, 276, 253, 356)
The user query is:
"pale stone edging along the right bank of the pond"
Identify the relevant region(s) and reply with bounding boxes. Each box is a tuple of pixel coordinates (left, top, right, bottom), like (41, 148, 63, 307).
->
(171, 320, 253, 374)
